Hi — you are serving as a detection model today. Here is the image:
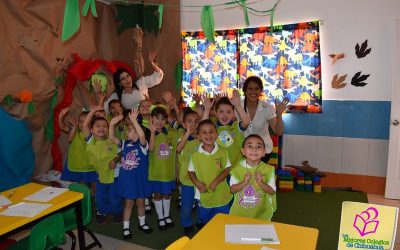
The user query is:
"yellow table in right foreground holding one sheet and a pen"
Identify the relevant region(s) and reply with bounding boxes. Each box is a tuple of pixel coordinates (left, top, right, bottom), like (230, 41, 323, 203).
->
(183, 214, 318, 250)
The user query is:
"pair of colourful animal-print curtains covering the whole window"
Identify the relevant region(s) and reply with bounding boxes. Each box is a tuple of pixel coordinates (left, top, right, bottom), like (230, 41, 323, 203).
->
(182, 21, 322, 113)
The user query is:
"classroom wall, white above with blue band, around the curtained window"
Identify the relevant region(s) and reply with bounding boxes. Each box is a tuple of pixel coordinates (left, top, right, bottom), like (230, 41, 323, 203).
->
(181, 0, 400, 193)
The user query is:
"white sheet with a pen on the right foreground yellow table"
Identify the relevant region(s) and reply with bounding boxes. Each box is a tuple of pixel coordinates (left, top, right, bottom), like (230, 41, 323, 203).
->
(225, 224, 280, 245)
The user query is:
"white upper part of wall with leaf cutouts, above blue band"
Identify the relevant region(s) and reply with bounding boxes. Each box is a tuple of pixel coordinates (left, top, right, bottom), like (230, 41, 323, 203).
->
(181, 0, 400, 101)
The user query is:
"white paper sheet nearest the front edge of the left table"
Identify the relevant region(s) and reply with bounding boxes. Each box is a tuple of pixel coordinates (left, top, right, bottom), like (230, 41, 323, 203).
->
(0, 202, 53, 217)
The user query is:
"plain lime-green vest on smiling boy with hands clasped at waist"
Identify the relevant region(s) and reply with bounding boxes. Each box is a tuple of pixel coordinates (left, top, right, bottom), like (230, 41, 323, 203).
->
(191, 148, 232, 208)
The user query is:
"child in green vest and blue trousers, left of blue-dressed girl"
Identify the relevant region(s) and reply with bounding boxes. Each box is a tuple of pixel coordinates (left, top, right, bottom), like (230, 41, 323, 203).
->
(83, 106, 122, 224)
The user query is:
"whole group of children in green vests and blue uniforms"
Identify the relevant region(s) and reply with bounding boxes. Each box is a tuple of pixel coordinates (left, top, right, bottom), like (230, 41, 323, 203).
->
(59, 87, 276, 239)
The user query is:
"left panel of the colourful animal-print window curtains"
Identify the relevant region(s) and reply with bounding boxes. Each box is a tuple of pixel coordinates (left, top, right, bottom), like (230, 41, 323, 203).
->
(182, 31, 237, 106)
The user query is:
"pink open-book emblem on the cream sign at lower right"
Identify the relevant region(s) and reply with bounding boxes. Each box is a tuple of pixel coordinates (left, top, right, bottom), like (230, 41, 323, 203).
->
(353, 207, 379, 237)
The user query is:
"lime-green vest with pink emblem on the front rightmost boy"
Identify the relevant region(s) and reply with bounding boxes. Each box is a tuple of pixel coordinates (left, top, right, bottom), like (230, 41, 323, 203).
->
(229, 161, 276, 220)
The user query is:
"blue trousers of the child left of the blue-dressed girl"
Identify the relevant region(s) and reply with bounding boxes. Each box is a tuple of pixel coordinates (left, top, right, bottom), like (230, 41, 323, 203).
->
(95, 178, 123, 215)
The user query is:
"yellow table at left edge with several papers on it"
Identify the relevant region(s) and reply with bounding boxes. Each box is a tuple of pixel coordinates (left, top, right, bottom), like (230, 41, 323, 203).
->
(0, 183, 85, 249)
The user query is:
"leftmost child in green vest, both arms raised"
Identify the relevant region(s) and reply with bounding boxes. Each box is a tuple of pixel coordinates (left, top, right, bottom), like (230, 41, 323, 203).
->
(59, 108, 98, 186)
